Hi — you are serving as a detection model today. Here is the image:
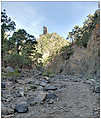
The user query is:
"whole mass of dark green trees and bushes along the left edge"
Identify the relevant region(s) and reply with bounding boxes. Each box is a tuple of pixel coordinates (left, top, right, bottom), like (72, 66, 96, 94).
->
(1, 10, 37, 67)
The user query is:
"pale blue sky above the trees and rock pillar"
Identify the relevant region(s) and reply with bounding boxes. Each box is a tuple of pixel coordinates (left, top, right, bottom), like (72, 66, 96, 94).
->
(1, 1, 98, 38)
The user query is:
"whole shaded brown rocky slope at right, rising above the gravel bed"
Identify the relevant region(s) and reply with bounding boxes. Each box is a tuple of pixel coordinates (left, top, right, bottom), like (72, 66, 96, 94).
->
(48, 18, 100, 80)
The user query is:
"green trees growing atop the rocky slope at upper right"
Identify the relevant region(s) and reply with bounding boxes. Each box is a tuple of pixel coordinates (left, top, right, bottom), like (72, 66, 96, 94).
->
(67, 10, 100, 47)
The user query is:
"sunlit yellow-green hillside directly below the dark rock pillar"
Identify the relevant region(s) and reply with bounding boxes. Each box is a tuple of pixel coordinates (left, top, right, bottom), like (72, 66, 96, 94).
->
(36, 33, 69, 66)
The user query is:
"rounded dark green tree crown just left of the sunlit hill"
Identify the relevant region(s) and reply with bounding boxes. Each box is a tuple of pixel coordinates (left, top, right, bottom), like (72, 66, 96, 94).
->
(11, 29, 36, 55)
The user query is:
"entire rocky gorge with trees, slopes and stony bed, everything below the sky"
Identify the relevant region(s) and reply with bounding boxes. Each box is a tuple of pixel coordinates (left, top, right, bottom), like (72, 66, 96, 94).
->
(1, 6, 100, 118)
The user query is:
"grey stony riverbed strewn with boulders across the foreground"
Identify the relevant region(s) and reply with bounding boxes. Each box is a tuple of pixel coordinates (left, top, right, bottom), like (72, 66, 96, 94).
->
(1, 69, 100, 118)
